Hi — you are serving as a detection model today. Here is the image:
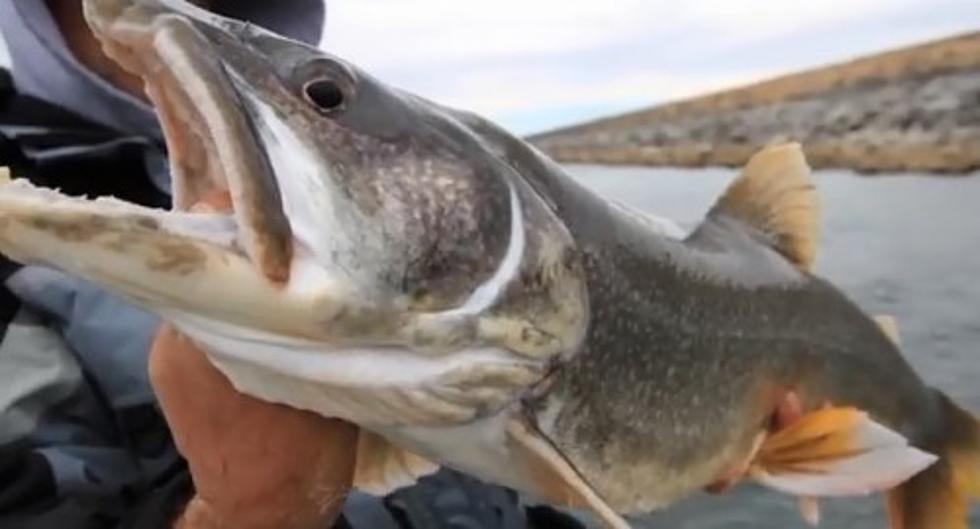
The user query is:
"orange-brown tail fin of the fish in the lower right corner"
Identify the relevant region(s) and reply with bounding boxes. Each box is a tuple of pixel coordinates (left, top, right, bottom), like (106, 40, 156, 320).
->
(886, 391, 980, 529)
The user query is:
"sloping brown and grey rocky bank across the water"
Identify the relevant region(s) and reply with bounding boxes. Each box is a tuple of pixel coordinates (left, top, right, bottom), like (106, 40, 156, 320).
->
(530, 32, 980, 173)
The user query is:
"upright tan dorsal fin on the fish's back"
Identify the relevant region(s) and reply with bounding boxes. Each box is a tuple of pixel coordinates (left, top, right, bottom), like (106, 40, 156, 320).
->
(708, 143, 820, 270)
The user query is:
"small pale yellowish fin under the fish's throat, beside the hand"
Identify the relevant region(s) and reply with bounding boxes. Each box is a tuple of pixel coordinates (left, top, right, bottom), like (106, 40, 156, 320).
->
(354, 429, 439, 496)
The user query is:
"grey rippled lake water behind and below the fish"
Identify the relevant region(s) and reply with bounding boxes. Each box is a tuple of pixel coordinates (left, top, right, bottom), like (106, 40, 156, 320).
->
(569, 166, 980, 529)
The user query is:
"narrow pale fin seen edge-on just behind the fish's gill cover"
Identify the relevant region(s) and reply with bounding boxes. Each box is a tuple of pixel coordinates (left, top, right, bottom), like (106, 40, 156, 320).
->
(507, 420, 630, 529)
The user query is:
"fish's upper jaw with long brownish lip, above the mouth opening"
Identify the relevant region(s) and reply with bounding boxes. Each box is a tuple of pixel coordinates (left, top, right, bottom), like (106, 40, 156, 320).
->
(84, 0, 293, 282)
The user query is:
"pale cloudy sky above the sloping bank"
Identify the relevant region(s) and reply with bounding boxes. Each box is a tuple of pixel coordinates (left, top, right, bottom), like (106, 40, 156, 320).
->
(0, 0, 980, 133)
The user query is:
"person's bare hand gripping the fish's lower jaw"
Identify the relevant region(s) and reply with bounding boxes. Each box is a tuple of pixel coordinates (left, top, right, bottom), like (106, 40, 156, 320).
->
(149, 194, 358, 529)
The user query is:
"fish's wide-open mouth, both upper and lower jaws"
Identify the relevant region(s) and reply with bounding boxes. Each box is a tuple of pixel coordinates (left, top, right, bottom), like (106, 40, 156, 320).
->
(2, 0, 353, 338)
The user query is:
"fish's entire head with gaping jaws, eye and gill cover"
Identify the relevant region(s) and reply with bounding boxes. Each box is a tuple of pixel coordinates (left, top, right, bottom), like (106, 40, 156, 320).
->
(0, 0, 588, 424)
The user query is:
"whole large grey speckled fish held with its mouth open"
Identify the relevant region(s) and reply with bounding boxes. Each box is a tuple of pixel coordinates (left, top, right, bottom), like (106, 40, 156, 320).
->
(0, 0, 980, 529)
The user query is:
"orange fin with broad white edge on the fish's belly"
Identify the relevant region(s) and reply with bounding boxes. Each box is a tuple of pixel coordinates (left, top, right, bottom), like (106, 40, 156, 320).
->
(750, 408, 936, 497)
